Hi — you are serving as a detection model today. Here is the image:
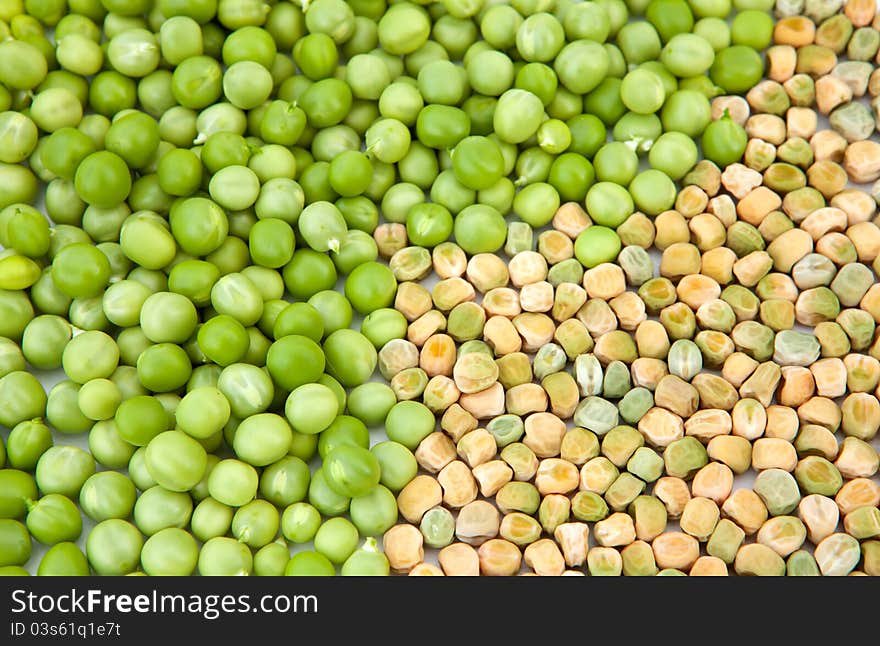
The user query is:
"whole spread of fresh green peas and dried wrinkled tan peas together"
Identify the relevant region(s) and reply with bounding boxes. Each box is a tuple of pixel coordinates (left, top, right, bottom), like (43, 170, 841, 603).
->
(0, 0, 880, 576)
